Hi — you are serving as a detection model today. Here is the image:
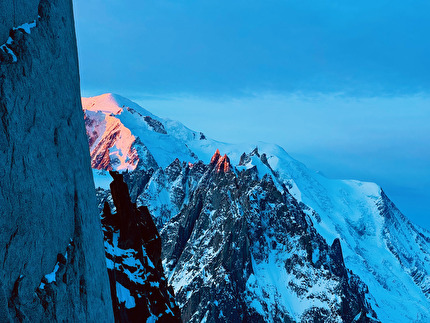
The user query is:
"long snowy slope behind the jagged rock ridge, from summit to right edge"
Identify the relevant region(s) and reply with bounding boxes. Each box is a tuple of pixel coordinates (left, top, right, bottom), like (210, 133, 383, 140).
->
(83, 94, 430, 322)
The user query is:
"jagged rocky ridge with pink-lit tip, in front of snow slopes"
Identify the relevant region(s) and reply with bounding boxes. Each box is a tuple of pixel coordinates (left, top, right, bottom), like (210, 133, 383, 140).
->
(157, 152, 377, 322)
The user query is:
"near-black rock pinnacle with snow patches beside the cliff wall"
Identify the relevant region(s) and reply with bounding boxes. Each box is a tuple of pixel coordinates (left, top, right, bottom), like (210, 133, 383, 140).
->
(102, 172, 181, 322)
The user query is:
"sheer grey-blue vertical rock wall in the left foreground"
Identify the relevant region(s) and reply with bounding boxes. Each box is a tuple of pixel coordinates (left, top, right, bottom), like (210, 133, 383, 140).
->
(0, 0, 113, 322)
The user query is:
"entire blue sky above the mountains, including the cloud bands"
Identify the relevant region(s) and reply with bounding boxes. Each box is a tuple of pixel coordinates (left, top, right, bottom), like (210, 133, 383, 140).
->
(74, 0, 430, 229)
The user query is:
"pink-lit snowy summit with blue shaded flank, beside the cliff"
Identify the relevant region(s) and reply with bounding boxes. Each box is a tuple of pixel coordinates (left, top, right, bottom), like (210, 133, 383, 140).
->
(82, 94, 197, 170)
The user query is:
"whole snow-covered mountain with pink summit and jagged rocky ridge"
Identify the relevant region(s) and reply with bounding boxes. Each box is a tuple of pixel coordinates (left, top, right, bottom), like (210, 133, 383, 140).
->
(83, 94, 430, 322)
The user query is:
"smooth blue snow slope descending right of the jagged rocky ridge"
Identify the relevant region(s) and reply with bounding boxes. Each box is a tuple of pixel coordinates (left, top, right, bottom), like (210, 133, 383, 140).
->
(260, 147, 430, 322)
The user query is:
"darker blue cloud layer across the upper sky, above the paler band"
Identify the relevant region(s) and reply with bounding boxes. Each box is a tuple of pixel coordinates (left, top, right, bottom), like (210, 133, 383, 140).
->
(75, 0, 430, 96)
